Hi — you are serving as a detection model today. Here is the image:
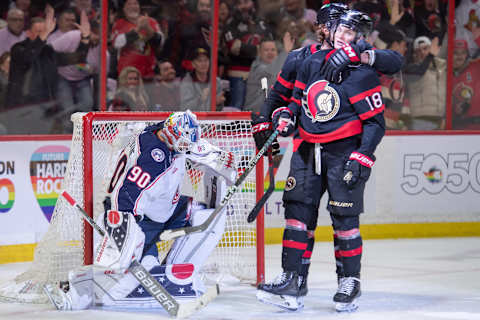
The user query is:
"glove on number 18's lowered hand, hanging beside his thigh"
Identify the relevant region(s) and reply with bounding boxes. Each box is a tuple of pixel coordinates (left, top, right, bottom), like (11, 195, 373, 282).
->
(343, 151, 375, 189)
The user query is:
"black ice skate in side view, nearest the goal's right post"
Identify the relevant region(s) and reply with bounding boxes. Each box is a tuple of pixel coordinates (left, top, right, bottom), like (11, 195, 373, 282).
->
(257, 271, 303, 311)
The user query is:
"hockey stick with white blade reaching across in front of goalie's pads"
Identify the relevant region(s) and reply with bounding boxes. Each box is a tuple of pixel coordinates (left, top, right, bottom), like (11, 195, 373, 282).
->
(160, 122, 287, 240)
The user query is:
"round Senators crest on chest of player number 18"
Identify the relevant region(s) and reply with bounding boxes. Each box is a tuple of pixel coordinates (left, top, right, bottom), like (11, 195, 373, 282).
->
(302, 80, 340, 122)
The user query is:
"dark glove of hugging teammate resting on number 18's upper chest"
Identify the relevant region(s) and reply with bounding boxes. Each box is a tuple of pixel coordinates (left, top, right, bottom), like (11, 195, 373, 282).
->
(320, 45, 360, 83)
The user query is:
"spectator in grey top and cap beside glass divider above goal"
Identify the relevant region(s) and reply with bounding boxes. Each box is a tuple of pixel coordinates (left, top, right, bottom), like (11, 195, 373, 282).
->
(180, 48, 225, 111)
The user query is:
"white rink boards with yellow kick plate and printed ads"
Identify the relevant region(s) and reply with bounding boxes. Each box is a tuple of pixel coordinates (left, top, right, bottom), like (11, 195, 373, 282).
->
(0, 134, 480, 263)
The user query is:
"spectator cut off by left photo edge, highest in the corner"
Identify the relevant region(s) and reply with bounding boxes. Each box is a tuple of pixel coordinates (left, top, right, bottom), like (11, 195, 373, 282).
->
(0, 8, 26, 55)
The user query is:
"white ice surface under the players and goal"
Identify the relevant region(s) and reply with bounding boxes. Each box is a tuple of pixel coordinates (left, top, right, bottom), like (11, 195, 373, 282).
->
(0, 237, 480, 320)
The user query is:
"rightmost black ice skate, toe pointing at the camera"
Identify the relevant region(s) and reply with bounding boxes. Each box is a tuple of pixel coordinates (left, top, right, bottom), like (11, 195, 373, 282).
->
(333, 277, 362, 312)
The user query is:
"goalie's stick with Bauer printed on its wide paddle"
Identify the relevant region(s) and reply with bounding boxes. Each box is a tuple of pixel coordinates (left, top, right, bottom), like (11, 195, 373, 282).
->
(62, 191, 219, 318)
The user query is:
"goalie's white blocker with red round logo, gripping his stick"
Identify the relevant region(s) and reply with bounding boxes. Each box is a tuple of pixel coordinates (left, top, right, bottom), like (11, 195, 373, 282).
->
(94, 210, 145, 270)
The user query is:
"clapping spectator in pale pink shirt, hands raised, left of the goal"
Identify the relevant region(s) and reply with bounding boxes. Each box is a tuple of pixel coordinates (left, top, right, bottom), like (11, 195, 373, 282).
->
(51, 11, 104, 133)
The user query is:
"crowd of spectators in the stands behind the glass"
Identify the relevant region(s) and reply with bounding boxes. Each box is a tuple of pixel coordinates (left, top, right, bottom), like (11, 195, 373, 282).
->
(0, 0, 480, 134)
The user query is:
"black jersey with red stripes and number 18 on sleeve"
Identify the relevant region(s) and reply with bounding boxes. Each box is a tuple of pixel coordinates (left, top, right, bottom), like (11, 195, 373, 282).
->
(289, 50, 385, 152)
